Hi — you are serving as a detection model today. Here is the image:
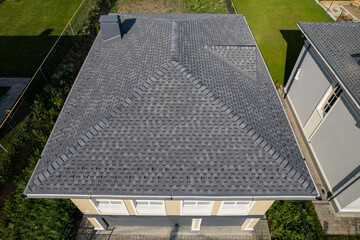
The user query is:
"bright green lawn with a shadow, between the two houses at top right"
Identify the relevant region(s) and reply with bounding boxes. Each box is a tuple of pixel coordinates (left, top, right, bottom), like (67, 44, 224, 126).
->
(233, 0, 332, 84)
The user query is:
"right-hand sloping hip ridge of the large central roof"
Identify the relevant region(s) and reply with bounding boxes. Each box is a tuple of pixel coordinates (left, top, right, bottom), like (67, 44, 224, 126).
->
(171, 61, 316, 193)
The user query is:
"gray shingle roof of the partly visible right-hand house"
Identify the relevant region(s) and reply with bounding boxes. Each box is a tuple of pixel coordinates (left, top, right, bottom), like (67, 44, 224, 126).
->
(297, 22, 360, 106)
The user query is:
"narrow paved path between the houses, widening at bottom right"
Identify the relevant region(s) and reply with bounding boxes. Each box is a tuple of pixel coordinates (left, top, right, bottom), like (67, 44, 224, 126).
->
(282, 91, 360, 235)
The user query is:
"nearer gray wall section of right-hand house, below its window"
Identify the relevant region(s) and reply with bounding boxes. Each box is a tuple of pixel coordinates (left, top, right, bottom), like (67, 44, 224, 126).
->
(310, 95, 360, 190)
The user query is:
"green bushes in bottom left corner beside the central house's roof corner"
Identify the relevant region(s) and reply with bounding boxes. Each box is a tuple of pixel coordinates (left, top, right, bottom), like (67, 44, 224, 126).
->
(0, 157, 81, 239)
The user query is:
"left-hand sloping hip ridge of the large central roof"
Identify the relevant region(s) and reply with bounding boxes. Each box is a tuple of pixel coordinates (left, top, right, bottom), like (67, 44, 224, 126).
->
(28, 62, 172, 191)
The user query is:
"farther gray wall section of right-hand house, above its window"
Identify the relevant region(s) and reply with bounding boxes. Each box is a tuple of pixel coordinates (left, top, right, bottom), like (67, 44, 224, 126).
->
(286, 46, 330, 127)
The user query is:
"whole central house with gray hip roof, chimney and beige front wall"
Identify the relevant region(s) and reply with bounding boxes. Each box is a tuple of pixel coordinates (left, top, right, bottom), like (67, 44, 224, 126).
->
(24, 14, 318, 231)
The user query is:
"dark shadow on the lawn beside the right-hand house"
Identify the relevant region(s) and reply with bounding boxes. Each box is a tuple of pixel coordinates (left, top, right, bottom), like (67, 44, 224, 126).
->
(280, 30, 304, 86)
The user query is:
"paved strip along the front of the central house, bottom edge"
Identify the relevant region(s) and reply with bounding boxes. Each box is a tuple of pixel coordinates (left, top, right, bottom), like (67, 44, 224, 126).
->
(77, 219, 271, 240)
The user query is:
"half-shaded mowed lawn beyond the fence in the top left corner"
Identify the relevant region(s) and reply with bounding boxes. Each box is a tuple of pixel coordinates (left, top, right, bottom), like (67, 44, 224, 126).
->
(0, 0, 82, 77)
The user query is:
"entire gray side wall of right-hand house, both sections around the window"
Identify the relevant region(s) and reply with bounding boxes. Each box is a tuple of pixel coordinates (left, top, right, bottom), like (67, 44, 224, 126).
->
(285, 43, 360, 212)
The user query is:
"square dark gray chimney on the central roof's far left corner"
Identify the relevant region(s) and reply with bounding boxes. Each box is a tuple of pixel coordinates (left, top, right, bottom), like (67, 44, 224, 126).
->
(99, 15, 122, 41)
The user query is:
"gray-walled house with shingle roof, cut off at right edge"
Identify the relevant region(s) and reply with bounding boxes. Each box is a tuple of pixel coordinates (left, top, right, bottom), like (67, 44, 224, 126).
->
(285, 23, 360, 214)
